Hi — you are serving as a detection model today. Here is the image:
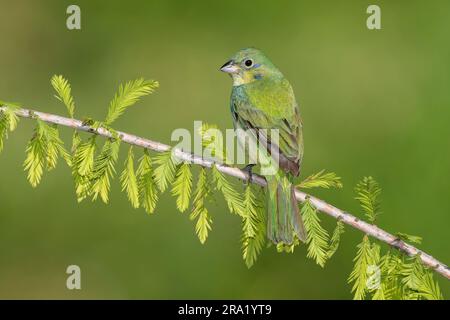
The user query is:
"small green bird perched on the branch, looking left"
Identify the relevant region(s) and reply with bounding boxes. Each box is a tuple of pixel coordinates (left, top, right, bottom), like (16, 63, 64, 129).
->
(220, 48, 306, 244)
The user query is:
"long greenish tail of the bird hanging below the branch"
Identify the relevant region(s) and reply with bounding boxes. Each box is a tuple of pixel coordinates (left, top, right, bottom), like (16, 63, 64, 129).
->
(267, 175, 306, 244)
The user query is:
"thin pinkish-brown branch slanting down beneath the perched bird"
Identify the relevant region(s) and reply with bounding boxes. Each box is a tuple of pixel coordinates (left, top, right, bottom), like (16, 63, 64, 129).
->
(0, 107, 450, 279)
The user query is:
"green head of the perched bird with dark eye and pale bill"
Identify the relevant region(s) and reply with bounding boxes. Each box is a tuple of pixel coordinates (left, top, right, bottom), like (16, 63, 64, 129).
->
(220, 48, 281, 86)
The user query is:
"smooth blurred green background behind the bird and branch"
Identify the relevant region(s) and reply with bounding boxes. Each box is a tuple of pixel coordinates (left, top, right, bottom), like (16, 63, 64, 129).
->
(0, 0, 450, 299)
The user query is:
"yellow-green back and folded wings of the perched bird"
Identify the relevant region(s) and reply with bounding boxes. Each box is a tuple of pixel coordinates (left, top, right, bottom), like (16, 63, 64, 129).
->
(231, 79, 303, 175)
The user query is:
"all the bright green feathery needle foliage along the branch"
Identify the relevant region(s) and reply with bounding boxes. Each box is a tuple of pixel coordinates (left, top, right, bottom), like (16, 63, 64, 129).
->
(0, 76, 443, 300)
